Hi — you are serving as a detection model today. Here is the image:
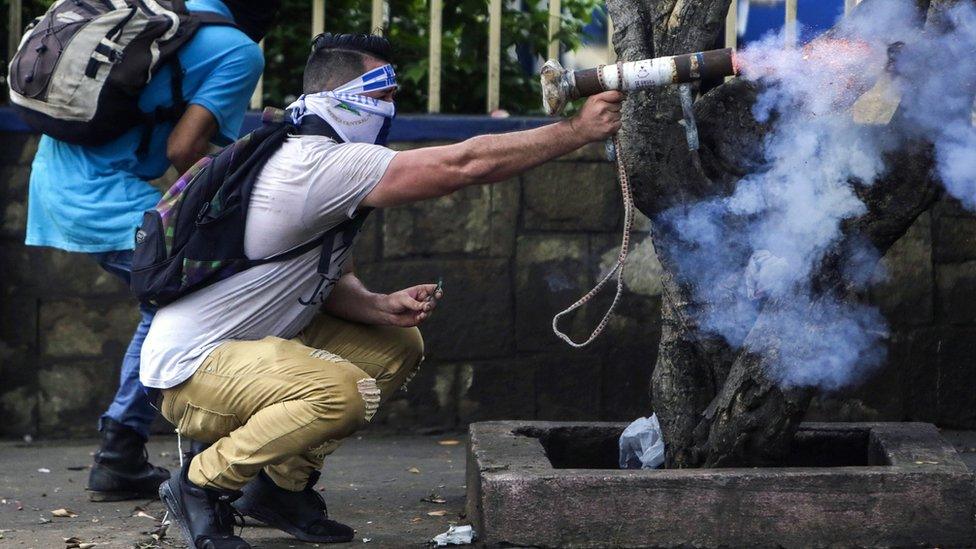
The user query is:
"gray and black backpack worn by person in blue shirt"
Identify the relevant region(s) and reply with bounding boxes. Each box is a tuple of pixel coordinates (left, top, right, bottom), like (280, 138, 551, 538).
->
(8, 0, 233, 152)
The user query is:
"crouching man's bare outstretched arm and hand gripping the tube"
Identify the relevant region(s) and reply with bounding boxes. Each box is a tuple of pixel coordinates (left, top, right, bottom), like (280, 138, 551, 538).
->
(362, 91, 623, 208)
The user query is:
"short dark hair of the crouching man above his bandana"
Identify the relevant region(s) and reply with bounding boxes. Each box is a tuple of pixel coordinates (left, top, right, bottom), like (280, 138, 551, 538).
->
(302, 32, 393, 93)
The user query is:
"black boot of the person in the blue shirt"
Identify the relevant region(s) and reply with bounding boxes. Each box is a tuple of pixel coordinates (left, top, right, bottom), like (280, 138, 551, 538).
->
(88, 418, 169, 501)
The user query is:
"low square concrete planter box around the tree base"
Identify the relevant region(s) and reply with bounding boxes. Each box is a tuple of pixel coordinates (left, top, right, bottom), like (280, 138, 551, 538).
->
(467, 421, 976, 547)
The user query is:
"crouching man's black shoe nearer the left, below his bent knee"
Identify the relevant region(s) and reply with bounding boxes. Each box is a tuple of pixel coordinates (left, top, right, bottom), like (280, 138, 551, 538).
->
(159, 459, 251, 549)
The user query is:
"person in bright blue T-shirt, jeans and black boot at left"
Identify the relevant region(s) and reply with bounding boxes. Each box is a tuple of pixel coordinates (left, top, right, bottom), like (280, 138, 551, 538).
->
(26, 0, 280, 501)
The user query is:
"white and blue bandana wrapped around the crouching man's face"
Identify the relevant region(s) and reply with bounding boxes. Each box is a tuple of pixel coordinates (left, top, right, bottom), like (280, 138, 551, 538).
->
(288, 65, 397, 145)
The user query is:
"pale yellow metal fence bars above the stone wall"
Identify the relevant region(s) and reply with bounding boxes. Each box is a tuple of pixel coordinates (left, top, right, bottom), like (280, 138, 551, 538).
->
(7, 0, 861, 113)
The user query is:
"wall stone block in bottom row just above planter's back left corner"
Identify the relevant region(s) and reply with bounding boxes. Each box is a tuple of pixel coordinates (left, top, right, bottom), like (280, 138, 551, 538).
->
(458, 359, 536, 425)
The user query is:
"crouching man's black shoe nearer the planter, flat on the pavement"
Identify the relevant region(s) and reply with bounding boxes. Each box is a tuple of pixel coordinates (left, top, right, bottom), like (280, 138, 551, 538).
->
(234, 471, 356, 543)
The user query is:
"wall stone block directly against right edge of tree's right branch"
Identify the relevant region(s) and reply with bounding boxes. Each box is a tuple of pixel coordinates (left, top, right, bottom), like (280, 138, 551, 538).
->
(871, 212, 934, 326)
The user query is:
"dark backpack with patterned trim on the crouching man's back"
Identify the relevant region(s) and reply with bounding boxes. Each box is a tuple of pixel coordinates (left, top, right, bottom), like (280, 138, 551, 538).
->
(130, 109, 369, 307)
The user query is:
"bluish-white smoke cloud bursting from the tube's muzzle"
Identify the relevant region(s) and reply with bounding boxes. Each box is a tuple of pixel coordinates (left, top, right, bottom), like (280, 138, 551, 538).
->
(659, 0, 976, 390)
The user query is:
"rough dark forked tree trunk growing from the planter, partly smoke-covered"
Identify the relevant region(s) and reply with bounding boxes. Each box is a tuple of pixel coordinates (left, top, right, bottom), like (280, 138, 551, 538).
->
(608, 0, 946, 467)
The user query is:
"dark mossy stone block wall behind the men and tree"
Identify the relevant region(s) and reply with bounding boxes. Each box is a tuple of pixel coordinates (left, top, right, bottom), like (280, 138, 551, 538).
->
(0, 128, 976, 436)
